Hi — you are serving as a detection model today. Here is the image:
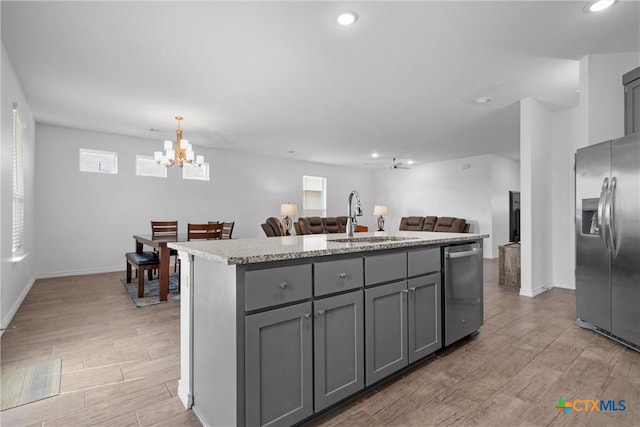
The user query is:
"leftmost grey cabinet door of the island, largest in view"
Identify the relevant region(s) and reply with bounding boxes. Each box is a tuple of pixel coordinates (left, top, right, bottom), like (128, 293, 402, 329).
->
(245, 302, 313, 426)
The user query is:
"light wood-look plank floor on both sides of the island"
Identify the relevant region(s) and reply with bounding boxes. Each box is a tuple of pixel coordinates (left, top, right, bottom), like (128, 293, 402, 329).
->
(0, 260, 640, 427)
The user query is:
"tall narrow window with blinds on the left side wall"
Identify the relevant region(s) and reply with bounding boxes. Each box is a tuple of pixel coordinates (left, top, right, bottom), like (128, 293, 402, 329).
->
(11, 105, 24, 256)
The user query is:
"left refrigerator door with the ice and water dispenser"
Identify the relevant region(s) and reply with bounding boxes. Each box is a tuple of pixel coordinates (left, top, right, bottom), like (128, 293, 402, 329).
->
(575, 141, 611, 331)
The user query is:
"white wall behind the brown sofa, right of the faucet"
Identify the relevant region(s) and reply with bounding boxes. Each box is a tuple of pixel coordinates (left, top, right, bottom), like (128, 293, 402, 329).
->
(375, 155, 520, 258)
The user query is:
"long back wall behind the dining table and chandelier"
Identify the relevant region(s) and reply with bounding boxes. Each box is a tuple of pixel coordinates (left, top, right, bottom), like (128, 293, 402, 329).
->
(35, 125, 375, 277)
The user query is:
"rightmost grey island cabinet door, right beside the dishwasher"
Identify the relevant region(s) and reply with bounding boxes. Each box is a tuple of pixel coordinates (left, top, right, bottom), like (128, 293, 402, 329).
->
(408, 273, 442, 363)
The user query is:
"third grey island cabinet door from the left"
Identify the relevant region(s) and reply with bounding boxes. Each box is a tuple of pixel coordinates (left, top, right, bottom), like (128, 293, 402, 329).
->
(364, 281, 409, 385)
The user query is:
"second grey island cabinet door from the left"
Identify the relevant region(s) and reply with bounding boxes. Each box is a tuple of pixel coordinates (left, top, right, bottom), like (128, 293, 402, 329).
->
(313, 291, 364, 412)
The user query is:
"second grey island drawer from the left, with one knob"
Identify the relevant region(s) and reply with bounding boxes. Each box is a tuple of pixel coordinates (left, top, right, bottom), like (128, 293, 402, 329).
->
(313, 258, 364, 296)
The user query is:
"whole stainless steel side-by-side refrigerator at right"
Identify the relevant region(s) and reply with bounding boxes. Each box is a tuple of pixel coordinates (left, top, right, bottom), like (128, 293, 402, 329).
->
(575, 133, 640, 349)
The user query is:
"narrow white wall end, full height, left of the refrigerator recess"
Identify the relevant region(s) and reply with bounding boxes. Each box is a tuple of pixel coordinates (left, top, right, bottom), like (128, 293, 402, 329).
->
(520, 98, 553, 297)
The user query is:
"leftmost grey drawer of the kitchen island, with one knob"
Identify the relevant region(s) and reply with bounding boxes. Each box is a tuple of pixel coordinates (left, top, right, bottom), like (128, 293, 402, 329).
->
(244, 264, 311, 311)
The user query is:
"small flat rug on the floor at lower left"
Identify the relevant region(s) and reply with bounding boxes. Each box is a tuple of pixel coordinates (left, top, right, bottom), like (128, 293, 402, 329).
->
(1, 359, 62, 411)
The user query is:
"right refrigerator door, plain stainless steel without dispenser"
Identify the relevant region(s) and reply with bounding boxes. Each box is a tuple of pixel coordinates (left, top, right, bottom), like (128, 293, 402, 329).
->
(608, 133, 640, 345)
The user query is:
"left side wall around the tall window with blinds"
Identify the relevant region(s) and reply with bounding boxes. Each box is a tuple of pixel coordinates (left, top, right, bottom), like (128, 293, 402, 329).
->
(0, 45, 35, 330)
